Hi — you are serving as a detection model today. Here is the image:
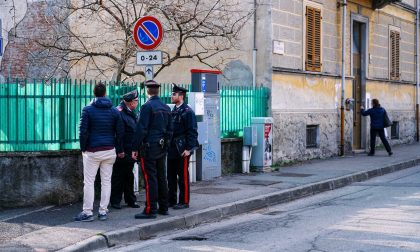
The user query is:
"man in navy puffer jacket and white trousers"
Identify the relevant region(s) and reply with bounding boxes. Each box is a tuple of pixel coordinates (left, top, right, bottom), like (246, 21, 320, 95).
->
(74, 83, 124, 221)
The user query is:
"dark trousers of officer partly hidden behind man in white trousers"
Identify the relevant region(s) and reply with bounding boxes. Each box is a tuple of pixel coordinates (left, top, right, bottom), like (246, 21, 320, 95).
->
(110, 158, 137, 205)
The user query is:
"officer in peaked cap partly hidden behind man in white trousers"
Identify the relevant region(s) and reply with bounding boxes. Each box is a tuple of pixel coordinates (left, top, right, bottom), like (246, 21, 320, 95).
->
(111, 90, 140, 209)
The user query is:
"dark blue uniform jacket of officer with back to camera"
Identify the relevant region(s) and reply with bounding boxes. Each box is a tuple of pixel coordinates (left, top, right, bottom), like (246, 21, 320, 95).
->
(133, 96, 172, 159)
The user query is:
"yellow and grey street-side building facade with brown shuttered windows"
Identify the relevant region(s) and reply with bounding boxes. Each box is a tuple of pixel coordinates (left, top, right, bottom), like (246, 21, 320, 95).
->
(271, 0, 416, 162)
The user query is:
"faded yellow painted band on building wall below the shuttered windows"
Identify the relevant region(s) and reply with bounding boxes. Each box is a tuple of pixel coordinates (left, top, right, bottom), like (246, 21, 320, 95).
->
(272, 73, 415, 111)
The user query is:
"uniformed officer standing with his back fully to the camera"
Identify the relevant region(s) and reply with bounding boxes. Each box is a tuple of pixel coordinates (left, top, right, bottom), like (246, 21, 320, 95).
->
(132, 80, 172, 219)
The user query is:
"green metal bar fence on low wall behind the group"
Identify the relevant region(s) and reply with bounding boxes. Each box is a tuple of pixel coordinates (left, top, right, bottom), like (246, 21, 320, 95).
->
(0, 79, 268, 152)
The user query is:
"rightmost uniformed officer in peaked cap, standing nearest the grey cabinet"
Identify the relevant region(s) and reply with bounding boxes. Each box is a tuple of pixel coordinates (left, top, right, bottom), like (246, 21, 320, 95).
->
(168, 84, 198, 209)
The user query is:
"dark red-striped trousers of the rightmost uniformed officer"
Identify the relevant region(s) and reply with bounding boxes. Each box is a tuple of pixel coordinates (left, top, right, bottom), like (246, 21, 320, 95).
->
(168, 156, 190, 205)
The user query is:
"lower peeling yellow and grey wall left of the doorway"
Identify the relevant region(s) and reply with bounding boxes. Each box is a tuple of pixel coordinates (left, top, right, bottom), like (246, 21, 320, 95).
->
(272, 73, 353, 163)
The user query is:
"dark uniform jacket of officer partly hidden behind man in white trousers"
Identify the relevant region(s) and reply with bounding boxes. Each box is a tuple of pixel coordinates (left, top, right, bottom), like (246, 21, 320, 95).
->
(117, 101, 137, 158)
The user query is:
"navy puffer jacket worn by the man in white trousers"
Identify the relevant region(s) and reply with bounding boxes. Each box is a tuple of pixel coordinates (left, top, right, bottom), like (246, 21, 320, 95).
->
(79, 97, 124, 153)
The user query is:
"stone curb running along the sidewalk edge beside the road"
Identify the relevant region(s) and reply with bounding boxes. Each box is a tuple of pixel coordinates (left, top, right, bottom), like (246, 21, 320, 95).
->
(60, 157, 420, 252)
